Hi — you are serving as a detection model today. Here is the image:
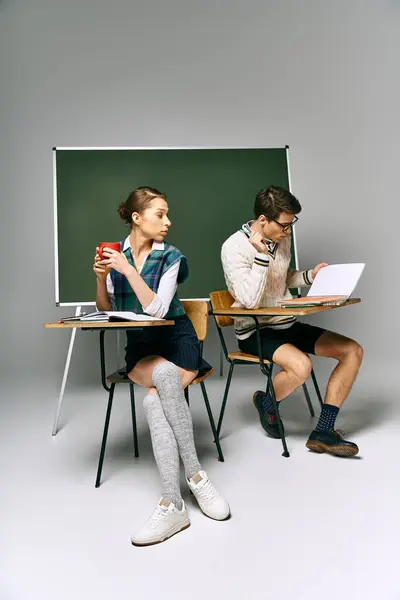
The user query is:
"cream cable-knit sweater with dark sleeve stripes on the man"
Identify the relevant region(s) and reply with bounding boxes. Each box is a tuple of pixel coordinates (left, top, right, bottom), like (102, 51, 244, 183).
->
(221, 221, 312, 340)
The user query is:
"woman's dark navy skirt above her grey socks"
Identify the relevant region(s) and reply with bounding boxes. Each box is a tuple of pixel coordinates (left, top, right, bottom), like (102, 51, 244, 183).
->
(125, 315, 212, 375)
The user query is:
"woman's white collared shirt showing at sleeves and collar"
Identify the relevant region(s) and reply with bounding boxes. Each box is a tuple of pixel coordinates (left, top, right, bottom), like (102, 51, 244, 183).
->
(106, 235, 181, 319)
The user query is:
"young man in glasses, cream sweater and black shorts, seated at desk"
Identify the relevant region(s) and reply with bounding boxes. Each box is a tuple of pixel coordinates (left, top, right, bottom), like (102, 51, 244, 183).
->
(221, 186, 363, 457)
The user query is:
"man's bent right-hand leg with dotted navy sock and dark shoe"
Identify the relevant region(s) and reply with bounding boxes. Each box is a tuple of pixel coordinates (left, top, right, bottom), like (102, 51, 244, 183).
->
(306, 331, 363, 456)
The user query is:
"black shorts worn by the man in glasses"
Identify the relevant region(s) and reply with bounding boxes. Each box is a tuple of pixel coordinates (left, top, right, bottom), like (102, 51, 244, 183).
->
(239, 321, 326, 361)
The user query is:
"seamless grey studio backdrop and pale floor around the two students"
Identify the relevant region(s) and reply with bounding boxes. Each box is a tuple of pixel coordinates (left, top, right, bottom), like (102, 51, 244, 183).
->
(0, 0, 400, 600)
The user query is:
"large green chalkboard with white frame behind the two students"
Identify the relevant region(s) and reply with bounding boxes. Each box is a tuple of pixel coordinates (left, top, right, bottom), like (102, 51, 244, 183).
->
(54, 148, 289, 305)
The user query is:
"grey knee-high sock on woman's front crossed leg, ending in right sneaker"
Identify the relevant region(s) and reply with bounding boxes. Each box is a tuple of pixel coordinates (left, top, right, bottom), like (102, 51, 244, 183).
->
(153, 362, 201, 478)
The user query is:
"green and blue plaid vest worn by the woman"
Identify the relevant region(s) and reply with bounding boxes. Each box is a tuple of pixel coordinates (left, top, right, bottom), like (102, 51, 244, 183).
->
(110, 241, 189, 319)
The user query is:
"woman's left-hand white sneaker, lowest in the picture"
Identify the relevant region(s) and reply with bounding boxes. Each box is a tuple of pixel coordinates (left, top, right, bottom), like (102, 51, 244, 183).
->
(131, 498, 190, 546)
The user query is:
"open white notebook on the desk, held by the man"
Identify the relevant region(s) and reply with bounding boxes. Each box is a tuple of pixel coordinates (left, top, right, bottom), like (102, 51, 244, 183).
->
(279, 263, 365, 308)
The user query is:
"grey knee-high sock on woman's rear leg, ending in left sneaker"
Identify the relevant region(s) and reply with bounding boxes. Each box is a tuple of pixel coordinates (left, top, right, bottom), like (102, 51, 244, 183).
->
(143, 394, 182, 510)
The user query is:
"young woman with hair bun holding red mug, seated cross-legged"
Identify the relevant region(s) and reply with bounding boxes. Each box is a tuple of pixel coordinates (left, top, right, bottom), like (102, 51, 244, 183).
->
(93, 187, 230, 546)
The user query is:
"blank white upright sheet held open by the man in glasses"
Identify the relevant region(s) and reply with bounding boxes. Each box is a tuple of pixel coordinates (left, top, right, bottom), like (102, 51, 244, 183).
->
(307, 263, 365, 297)
